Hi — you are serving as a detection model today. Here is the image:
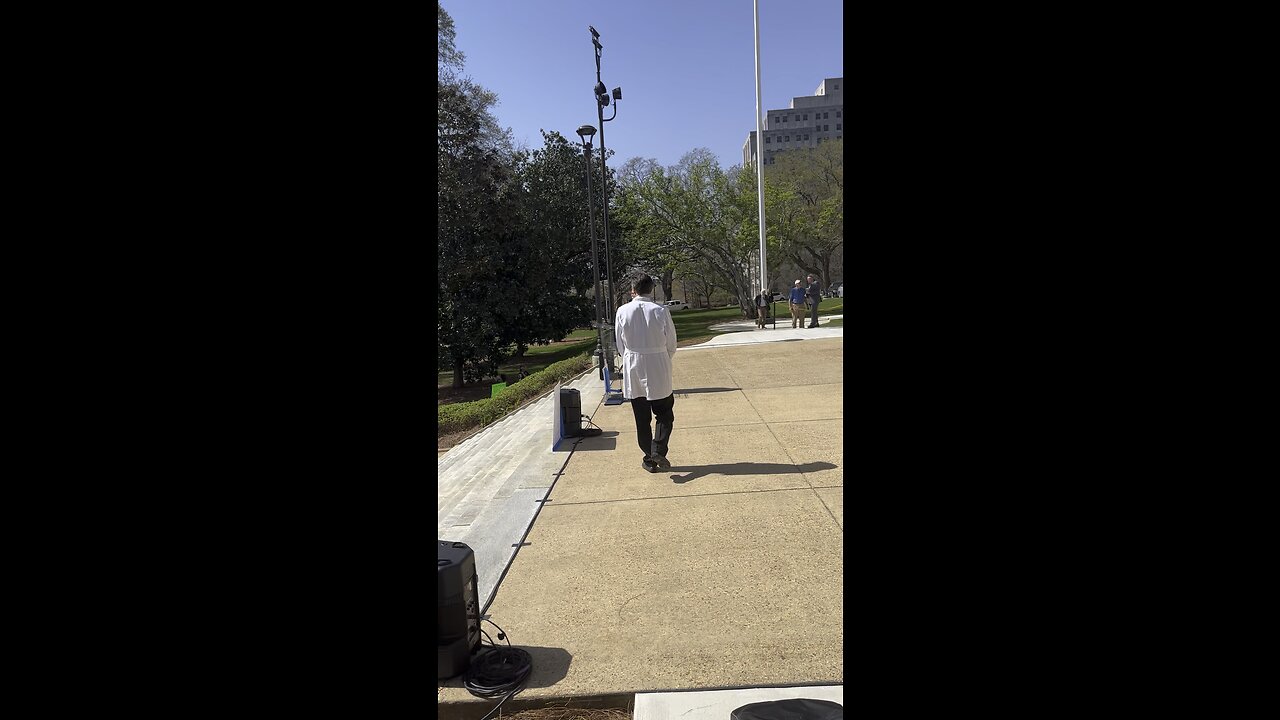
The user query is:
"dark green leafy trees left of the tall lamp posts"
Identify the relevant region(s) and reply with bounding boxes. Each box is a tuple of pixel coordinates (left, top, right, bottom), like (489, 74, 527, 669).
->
(435, 6, 594, 387)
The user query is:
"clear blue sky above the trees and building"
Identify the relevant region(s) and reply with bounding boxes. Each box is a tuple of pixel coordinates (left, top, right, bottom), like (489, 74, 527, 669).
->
(442, 0, 845, 169)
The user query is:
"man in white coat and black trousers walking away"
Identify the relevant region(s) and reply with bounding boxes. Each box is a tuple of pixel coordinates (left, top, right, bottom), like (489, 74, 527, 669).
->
(613, 275, 676, 473)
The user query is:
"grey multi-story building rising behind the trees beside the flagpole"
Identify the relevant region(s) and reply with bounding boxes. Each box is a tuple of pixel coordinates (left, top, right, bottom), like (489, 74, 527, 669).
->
(742, 77, 845, 165)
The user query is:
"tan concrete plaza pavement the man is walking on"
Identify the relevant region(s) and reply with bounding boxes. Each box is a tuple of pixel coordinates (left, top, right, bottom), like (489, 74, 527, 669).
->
(440, 335, 844, 711)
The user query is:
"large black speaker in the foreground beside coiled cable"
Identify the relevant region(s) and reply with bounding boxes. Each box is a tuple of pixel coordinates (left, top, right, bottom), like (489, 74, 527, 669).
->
(435, 541, 480, 680)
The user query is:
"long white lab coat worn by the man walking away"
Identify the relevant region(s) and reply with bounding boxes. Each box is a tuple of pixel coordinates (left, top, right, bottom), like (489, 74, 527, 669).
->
(613, 296, 676, 400)
